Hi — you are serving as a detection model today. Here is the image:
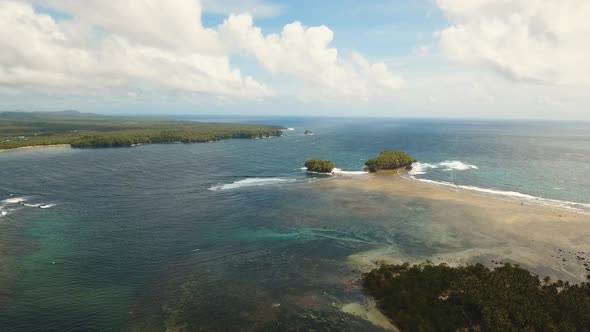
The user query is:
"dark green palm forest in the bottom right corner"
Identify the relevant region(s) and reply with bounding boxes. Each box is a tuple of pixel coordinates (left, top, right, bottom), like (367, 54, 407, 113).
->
(362, 263, 590, 331)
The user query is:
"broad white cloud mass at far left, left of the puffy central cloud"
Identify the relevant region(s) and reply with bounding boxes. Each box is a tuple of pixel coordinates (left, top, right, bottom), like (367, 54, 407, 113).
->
(0, 1, 273, 98)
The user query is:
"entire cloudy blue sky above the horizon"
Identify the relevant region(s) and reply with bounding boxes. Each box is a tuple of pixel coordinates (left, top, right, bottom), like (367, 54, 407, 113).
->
(0, 0, 590, 121)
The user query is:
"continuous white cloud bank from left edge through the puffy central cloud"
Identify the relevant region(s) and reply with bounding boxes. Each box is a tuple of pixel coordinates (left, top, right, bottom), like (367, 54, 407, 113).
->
(0, 0, 402, 99)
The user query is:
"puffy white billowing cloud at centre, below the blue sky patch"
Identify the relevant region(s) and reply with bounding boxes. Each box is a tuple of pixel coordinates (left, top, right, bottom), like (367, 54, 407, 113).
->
(219, 14, 403, 99)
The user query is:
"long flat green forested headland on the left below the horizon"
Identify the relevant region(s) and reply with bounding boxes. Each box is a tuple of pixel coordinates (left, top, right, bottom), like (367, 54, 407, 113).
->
(0, 111, 283, 149)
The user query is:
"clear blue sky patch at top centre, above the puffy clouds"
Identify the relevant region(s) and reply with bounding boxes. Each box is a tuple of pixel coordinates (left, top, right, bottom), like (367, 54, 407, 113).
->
(203, 0, 446, 58)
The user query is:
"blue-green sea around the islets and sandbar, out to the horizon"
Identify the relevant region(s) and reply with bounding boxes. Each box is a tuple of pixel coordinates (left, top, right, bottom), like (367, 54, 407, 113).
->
(0, 118, 590, 331)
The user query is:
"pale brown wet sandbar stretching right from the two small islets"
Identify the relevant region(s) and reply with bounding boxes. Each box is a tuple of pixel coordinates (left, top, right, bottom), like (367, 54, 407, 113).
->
(316, 172, 590, 282)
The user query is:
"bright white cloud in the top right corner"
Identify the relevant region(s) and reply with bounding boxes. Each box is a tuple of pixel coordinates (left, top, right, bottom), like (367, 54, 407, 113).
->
(437, 0, 590, 85)
